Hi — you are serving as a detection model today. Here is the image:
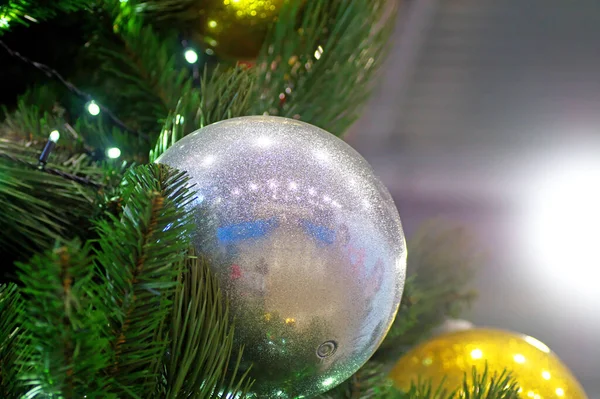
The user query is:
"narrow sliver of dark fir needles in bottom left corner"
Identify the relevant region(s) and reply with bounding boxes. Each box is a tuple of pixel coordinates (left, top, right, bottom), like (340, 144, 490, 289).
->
(0, 284, 27, 399)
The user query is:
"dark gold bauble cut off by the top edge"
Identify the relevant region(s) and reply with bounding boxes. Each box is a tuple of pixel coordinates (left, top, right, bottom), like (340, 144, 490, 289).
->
(192, 0, 286, 61)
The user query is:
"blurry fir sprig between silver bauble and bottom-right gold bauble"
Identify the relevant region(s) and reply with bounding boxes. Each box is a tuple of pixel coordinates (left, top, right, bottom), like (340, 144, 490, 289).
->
(375, 221, 482, 361)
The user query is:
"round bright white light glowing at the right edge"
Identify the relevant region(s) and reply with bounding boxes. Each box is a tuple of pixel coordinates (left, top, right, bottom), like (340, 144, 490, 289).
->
(523, 159, 600, 303)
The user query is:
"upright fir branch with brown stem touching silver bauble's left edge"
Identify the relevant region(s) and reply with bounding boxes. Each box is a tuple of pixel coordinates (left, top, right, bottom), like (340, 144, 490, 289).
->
(96, 164, 192, 398)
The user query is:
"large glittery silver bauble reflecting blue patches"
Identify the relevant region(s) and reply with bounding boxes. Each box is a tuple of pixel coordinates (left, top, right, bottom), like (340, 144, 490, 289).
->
(157, 116, 406, 398)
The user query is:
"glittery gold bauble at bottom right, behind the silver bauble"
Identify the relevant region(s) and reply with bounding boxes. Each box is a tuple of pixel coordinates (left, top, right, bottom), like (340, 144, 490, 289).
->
(390, 328, 587, 399)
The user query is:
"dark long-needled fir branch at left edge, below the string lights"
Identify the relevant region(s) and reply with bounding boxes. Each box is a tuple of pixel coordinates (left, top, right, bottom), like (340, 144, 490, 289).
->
(0, 139, 97, 260)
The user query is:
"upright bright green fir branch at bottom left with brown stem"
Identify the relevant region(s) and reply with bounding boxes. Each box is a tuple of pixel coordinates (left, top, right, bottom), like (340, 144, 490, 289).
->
(16, 242, 115, 399)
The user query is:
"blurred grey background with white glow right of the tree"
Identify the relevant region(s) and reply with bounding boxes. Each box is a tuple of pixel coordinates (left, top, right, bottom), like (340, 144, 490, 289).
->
(346, 0, 600, 399)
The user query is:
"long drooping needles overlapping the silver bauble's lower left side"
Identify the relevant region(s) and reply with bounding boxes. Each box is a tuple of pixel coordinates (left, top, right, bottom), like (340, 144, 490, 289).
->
(158, 251, 251, 399)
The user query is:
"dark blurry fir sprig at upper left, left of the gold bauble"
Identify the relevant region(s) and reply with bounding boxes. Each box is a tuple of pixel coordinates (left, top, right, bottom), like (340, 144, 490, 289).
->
(95, 6, 192, 137)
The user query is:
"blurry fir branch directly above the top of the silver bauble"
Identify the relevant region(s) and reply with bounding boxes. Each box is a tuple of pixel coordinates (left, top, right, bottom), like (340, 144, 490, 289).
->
(251, 0, 397, 136)
